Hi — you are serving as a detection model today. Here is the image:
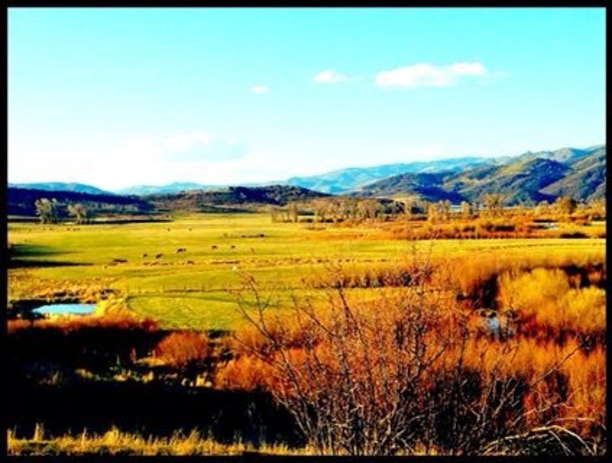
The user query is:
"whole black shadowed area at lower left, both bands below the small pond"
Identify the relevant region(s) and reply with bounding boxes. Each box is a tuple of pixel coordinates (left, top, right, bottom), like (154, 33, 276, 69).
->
(8, 322, 303, 446)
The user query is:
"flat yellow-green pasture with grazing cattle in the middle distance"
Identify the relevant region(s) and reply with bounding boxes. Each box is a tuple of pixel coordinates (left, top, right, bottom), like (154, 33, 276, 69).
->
(8, 213, 605, 329)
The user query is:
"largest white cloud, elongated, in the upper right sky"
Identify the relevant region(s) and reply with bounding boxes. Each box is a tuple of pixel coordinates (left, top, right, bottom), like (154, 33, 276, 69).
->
(376, 61, 488, 88)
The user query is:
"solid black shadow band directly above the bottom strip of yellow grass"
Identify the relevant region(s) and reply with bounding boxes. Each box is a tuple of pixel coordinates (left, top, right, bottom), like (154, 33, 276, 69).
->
(6, 378, 303, 446)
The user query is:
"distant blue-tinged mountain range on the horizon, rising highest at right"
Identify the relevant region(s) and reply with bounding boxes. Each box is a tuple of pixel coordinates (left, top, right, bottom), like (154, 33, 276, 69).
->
(9, 145, 606, 204)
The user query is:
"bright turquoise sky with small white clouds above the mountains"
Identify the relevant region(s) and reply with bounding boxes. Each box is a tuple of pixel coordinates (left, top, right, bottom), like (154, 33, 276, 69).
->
(8, 7, 606, 191)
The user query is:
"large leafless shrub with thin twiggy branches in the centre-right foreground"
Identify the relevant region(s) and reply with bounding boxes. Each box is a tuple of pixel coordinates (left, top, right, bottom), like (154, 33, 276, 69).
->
(230, 260, 594, 455)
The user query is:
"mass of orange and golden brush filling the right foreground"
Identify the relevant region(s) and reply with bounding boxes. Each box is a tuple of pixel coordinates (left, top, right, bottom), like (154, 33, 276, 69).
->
(215, 250, 605, 454)
